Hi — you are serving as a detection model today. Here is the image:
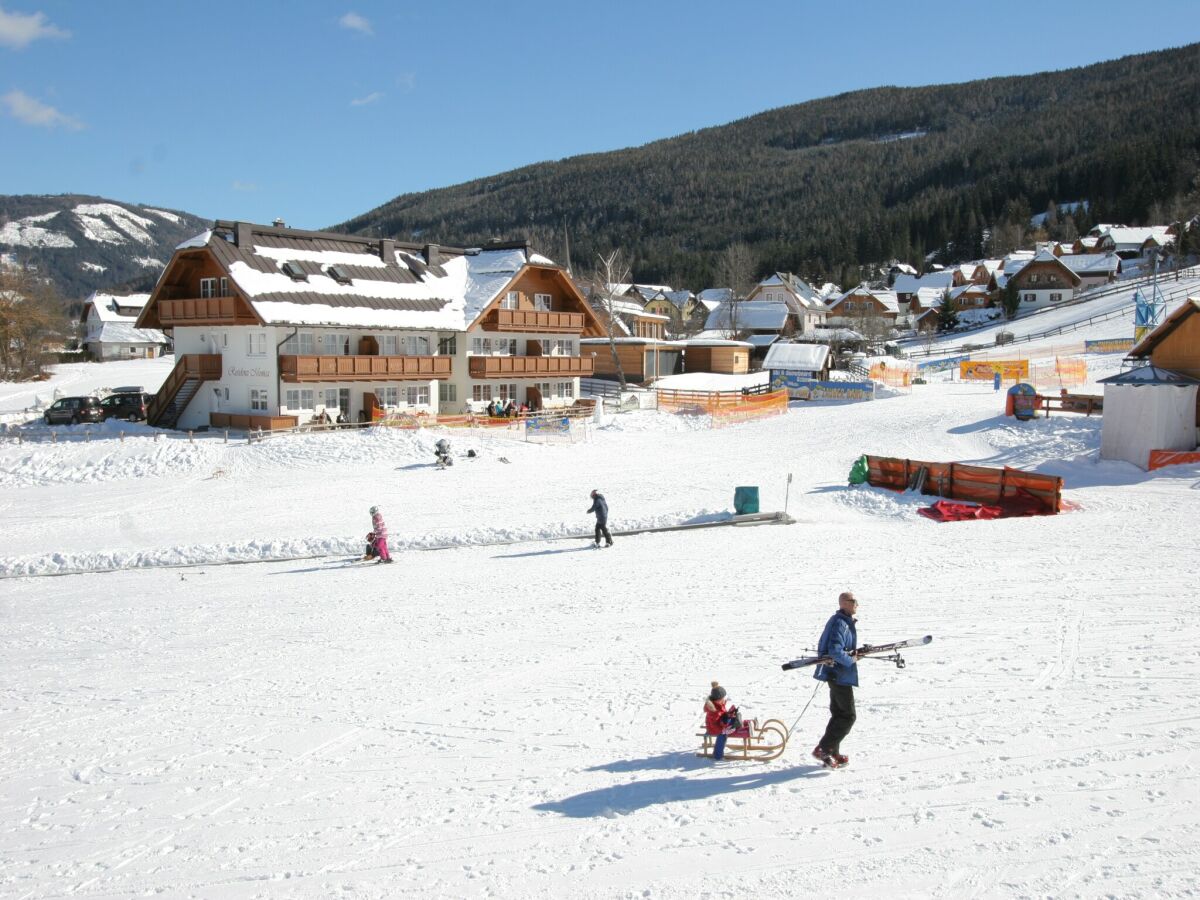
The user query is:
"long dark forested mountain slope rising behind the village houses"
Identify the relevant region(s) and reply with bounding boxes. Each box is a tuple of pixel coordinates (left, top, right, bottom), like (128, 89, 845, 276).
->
(337, 44, 1200, 288)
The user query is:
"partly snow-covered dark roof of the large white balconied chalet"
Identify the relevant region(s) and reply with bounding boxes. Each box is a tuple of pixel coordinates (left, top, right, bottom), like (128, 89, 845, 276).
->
(159, 222, 553, 331)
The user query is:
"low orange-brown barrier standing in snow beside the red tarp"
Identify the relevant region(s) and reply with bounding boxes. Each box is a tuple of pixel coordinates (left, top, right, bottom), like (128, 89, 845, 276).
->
(866, 456, 1062, 512)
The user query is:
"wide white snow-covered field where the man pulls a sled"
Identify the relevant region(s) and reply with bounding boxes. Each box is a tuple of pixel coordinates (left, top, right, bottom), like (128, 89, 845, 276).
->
(0, 345, 1200, 898)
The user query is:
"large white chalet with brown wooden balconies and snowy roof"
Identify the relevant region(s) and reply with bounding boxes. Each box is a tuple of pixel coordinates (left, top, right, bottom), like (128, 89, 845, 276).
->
(137, 221, 604, 428)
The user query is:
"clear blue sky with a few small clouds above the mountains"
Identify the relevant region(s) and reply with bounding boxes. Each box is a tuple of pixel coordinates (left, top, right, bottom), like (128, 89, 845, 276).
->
(0, 0, 1200, 228)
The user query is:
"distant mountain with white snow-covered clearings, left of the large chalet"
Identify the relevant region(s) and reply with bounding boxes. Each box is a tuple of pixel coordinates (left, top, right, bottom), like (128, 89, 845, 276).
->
(0, 194, 210, 304)
